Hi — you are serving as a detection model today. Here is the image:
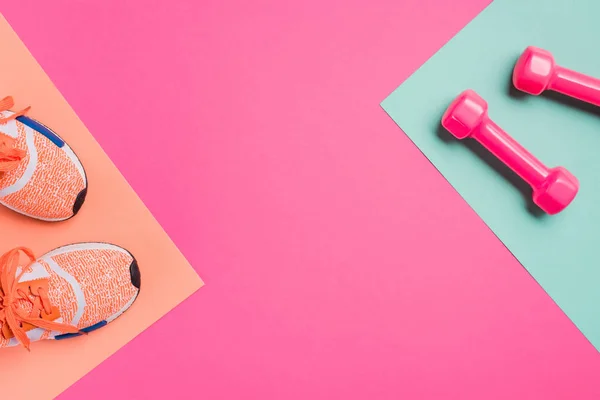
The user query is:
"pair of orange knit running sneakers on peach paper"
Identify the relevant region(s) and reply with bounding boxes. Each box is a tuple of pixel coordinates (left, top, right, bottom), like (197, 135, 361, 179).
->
(0, 97, 140, 349)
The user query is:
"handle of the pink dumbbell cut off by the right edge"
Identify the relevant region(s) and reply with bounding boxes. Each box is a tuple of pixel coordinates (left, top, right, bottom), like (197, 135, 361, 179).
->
(548, 65, 600, 106)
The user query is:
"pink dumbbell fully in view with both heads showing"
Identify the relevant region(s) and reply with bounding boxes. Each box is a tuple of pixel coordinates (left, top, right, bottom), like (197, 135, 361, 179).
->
(442, 90, 579, 214)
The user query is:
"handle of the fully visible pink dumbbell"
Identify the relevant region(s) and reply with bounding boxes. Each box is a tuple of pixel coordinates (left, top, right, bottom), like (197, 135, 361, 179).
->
(471, 117, 550, 188)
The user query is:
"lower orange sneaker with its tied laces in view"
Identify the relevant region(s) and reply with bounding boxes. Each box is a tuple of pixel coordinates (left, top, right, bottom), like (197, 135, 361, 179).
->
(0, 243, 140, 350)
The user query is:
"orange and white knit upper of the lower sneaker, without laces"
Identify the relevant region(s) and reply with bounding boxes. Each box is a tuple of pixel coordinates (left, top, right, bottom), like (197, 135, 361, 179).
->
(0, 243, 139, 347)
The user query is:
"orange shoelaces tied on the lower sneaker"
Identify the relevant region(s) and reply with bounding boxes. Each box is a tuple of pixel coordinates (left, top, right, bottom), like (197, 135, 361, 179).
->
(0, 247, 81, 350)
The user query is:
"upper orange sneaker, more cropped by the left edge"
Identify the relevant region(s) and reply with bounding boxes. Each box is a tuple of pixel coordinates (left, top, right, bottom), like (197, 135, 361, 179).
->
(0, 96, 87, 221)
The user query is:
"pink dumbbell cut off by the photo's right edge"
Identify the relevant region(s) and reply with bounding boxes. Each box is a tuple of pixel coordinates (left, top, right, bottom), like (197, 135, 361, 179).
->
(513, 46, 600, 106)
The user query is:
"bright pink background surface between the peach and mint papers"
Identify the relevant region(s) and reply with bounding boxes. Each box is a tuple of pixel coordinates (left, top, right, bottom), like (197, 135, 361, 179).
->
(2, 0, 600, 400)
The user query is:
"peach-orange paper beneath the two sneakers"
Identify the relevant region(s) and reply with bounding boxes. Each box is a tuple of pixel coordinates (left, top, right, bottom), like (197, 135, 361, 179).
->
(0, 15, 202, 400)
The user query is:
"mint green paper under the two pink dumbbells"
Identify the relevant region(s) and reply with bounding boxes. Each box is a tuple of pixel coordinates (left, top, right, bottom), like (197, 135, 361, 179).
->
(382, 0, 600, 350)
